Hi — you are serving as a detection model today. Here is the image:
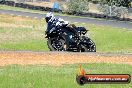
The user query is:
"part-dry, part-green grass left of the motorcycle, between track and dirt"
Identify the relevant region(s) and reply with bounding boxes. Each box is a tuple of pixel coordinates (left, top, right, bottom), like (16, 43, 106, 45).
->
(0, 15, 48, 51)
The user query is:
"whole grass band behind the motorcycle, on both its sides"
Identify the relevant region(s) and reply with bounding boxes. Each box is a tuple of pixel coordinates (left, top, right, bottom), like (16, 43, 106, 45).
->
(0, 15, 132, 53)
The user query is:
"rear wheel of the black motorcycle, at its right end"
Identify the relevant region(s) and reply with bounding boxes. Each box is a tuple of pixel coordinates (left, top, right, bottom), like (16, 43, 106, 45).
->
(81, 38, 96, 52)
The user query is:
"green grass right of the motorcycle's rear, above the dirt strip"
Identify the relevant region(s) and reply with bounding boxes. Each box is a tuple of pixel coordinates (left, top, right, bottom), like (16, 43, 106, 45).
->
(89, 25, 132, 53)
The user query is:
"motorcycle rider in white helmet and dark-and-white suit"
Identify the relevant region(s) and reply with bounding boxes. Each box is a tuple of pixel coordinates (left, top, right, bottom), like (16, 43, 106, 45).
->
(45, 12, 69, 32)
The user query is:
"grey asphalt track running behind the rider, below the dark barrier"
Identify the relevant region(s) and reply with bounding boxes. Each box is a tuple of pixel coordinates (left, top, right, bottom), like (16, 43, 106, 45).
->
(0, 10, 132, 30)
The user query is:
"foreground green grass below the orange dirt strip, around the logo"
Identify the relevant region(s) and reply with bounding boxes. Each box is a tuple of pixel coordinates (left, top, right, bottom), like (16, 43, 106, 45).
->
(0, 63, 132, 88)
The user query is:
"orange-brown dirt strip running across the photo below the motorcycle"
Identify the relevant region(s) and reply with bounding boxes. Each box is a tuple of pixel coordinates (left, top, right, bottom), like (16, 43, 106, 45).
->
(0, 51, 132, 66)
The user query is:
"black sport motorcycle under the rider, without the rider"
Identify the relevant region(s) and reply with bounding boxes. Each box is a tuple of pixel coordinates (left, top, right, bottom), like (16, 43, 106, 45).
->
(45, 25, 96, 52)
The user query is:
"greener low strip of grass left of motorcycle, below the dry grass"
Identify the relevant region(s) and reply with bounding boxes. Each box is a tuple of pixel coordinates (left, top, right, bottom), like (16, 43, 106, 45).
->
(0, 40, 48, 51)
